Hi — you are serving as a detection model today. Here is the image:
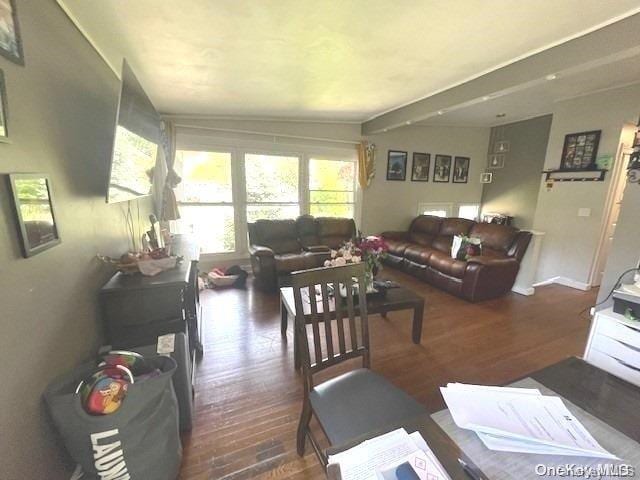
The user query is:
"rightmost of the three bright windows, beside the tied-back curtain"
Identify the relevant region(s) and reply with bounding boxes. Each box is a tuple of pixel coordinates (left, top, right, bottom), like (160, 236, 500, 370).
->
(309, 158, 356, 218)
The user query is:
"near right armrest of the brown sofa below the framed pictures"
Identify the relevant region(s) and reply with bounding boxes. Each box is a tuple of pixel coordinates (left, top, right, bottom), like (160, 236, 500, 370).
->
(462, 255, 520, 302)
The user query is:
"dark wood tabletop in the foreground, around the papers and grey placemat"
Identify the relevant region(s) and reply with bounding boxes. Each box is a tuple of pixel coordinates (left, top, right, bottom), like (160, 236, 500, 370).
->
(328, 357, 640, 480)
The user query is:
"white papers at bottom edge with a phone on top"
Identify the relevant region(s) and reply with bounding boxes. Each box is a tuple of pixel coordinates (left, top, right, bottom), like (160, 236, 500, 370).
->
(327, 428, 450, 480)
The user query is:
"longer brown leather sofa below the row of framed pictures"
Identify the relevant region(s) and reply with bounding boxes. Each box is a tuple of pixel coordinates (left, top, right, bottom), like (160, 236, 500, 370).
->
(381, 215, 531, 302)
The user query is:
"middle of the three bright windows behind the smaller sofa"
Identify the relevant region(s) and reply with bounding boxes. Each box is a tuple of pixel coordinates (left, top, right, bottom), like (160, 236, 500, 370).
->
(244, 153, 300, 222)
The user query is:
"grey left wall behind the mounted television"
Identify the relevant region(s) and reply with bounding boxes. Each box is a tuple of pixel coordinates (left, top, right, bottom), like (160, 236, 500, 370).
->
(0, 0, 151, 480)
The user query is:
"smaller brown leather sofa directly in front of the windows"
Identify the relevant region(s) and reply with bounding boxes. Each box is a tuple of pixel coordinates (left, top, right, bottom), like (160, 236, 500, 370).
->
(248, 215, 356, 290)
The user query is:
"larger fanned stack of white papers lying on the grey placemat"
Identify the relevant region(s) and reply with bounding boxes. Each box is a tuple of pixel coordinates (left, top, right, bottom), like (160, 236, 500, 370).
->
(440, 383, 618, 460)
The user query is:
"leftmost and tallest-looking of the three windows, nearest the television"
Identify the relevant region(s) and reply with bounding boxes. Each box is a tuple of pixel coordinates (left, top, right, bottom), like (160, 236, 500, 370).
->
(175, 150, 236, 253)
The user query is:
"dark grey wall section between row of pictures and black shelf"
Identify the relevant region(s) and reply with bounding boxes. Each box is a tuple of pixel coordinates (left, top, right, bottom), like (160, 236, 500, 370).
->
(482, 115, 551, 229)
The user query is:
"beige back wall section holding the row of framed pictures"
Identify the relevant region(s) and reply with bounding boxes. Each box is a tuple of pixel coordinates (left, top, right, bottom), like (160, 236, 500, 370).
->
(362, 125, 489, 234)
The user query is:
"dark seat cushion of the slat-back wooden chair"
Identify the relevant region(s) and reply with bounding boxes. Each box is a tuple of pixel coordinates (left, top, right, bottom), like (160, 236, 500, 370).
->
(309, 368, 427, 445)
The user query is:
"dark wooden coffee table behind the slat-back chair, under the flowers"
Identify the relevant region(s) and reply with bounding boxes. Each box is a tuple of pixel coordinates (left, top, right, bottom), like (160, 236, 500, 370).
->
(280, 286, 424, 369)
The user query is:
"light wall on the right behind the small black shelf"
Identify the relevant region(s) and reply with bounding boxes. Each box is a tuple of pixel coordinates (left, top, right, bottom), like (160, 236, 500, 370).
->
(534, 84, 640, 288)
